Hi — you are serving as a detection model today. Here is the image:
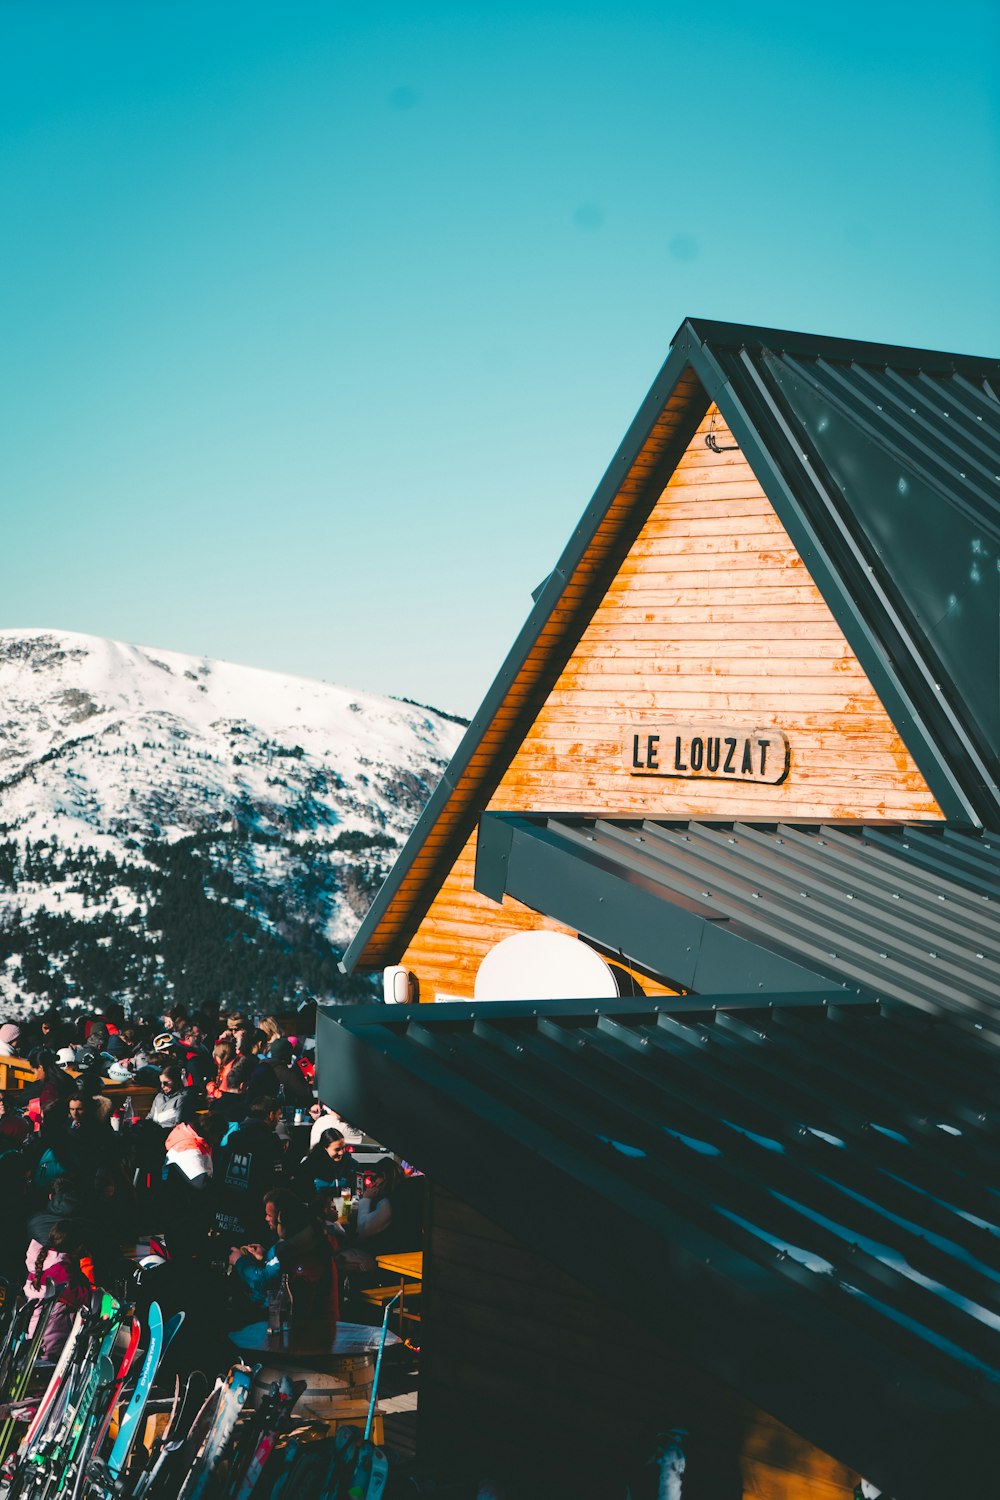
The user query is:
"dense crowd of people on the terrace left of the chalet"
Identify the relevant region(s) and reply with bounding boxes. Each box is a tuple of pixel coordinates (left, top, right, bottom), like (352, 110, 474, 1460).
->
(0, 1008, 423, 1365)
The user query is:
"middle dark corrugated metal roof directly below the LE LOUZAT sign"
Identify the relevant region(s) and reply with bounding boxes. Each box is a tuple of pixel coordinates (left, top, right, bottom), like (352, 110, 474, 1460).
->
(477, 813, 1000, 1035)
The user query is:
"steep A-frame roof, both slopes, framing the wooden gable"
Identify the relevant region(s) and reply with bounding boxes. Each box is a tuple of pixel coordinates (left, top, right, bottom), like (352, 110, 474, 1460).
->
(343, 320, 1000, 972)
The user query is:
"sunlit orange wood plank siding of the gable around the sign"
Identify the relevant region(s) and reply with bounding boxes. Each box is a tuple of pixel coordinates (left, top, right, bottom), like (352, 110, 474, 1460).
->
(400, 407, 942, 1001)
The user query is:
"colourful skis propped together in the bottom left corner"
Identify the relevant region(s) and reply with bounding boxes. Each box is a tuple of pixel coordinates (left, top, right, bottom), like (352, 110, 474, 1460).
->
(0, 1290, 388, 1500)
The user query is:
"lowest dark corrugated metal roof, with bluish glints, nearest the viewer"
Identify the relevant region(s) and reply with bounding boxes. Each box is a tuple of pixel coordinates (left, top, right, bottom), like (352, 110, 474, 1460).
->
(319, 993, 1000, 1500)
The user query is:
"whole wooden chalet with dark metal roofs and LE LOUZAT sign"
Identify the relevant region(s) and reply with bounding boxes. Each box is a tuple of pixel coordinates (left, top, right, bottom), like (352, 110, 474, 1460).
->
(318, 320, 1000, 1500)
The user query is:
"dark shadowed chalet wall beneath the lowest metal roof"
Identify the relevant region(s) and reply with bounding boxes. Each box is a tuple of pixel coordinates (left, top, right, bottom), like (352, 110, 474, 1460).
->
(418, 1184, 858, 1500)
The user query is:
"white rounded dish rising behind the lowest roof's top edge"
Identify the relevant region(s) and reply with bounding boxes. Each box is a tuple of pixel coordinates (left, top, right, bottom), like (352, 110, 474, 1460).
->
(474, 932, 619, 1001)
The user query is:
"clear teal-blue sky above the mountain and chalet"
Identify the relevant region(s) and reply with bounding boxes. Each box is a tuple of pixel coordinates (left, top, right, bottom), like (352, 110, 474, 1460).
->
(0, 0, 1000, 713)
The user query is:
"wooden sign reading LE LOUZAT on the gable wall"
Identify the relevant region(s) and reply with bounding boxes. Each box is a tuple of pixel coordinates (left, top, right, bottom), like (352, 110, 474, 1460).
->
(624, 725, 789, 786)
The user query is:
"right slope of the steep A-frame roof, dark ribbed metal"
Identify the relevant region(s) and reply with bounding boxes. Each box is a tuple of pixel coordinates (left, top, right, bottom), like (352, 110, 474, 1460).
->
(691, 324, 1000, 824)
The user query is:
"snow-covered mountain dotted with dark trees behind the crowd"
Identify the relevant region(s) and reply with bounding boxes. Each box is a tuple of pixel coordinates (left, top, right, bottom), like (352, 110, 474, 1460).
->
(0, 630, 462, 1019)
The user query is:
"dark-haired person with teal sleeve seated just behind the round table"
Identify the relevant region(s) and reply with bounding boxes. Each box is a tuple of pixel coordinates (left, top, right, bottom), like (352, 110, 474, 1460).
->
(229, 1190, 339, 1323)
